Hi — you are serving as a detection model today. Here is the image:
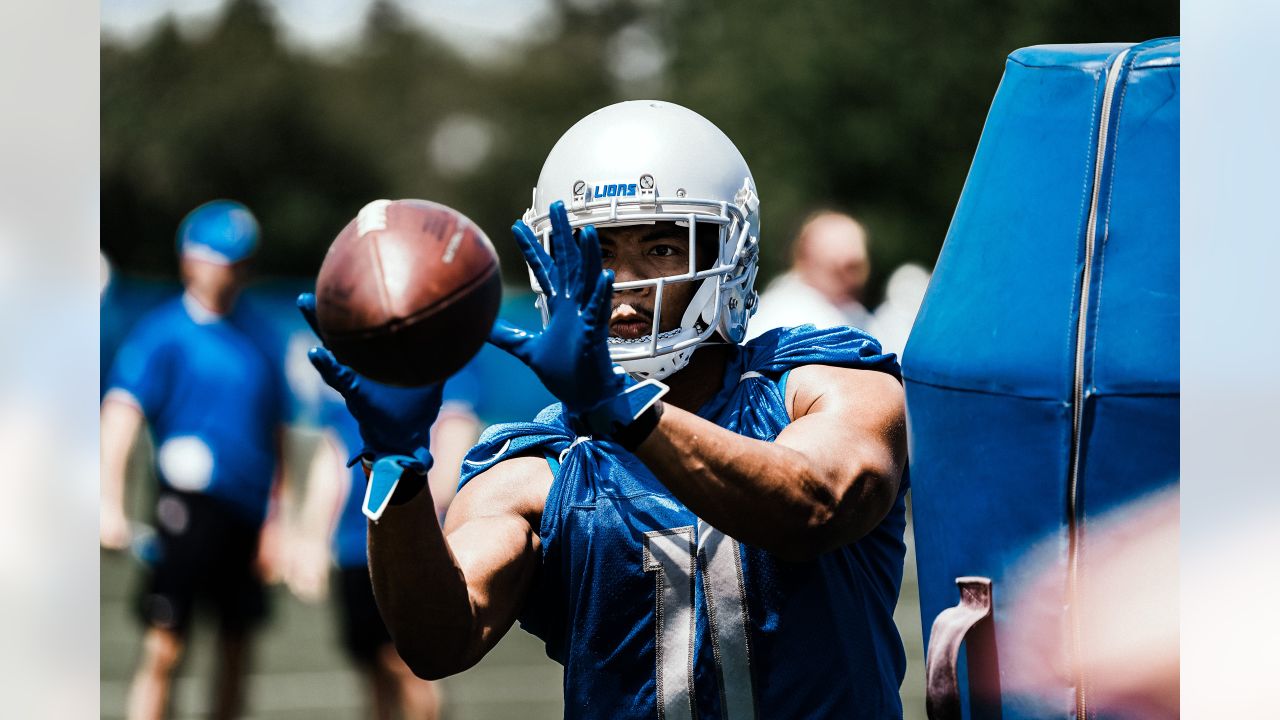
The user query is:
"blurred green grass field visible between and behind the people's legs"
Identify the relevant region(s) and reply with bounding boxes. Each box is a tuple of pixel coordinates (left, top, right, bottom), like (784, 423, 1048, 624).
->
(100, 427, 924, 720)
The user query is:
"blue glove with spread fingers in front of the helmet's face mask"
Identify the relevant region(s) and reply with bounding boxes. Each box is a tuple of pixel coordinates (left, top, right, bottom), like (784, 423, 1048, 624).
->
(489, 201, 667, 436)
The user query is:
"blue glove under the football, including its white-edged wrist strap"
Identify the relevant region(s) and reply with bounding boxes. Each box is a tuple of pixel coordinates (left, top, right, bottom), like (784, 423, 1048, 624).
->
(298, 292, 443, 520)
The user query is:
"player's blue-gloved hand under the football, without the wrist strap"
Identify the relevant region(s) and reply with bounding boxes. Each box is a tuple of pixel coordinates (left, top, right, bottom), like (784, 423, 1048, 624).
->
(298, 292, 443, 473)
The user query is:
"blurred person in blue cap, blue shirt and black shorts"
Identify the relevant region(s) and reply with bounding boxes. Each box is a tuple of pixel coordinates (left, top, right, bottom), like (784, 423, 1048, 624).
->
(100, 200, 283, 719)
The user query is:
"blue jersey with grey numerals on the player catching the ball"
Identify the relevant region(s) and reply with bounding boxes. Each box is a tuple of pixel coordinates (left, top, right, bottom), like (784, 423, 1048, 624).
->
(462, 325, 908, 720)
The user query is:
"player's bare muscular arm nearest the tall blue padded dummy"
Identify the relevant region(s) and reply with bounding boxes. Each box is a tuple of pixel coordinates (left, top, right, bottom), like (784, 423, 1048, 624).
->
(636, 365, 906, 559)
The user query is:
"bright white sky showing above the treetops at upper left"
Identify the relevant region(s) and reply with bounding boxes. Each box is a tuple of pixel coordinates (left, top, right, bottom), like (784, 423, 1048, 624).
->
(101, 0, 549, 60)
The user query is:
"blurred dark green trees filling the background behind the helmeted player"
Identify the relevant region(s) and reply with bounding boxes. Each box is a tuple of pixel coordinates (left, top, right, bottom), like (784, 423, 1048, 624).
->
(101, 0, 1179, 306)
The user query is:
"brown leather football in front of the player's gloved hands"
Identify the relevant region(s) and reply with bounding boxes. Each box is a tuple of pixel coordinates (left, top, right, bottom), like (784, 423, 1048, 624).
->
(316, 200, 502, 386)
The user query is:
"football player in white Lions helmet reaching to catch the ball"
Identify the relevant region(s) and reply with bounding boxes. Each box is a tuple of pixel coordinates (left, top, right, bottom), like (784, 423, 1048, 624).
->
(300, 101, 906, 719)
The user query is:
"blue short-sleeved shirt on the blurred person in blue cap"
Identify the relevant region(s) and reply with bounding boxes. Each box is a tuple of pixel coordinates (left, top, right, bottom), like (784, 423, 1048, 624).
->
(108, 296, 283, 521)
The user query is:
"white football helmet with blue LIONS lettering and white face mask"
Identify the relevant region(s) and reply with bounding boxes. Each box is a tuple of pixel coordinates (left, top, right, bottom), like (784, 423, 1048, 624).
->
(524, 100, 760, 379)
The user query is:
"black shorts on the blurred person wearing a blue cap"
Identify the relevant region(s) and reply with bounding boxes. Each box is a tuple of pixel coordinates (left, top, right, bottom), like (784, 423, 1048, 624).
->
(138, 488, 266, 634)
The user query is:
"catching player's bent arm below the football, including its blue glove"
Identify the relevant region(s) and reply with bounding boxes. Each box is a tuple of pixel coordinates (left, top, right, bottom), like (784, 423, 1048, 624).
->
(300, 289, 552, 679)
